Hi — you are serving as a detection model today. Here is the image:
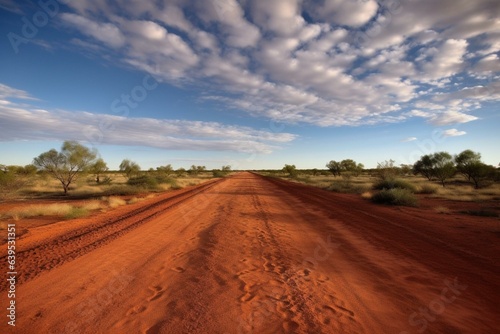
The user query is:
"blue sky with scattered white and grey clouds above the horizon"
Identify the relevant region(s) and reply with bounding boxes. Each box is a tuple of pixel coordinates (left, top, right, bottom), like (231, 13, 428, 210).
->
(0, 0, 500, 169)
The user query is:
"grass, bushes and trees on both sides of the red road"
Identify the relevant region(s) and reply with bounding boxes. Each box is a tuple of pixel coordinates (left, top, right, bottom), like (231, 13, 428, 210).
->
(0, 141, 500, 219)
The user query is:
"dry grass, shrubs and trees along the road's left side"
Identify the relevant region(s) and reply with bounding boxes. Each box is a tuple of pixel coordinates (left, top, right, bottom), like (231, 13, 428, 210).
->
(0, 141, 236, 220)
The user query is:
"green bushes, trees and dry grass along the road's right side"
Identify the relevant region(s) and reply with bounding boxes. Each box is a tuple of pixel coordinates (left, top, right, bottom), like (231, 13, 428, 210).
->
(258, 150, 500, 209)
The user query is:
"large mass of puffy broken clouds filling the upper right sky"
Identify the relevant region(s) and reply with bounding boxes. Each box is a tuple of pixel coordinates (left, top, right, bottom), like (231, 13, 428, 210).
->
(31, 0, 500, 126)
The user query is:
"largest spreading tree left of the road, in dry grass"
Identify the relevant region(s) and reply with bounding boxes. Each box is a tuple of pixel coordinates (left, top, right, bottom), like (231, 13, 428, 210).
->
(33, 141, 97, 194)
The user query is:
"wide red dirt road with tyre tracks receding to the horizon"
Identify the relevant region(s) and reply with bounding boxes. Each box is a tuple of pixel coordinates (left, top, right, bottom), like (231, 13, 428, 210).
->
(0, 173, 500, 334)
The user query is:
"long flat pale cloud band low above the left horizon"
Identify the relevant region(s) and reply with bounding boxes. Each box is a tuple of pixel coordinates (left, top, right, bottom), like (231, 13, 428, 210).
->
(0, 85, 296, 153)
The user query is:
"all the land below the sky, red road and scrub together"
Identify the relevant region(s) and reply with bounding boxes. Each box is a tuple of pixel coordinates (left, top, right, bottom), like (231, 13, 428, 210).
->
(0, 142, 500, 334)
